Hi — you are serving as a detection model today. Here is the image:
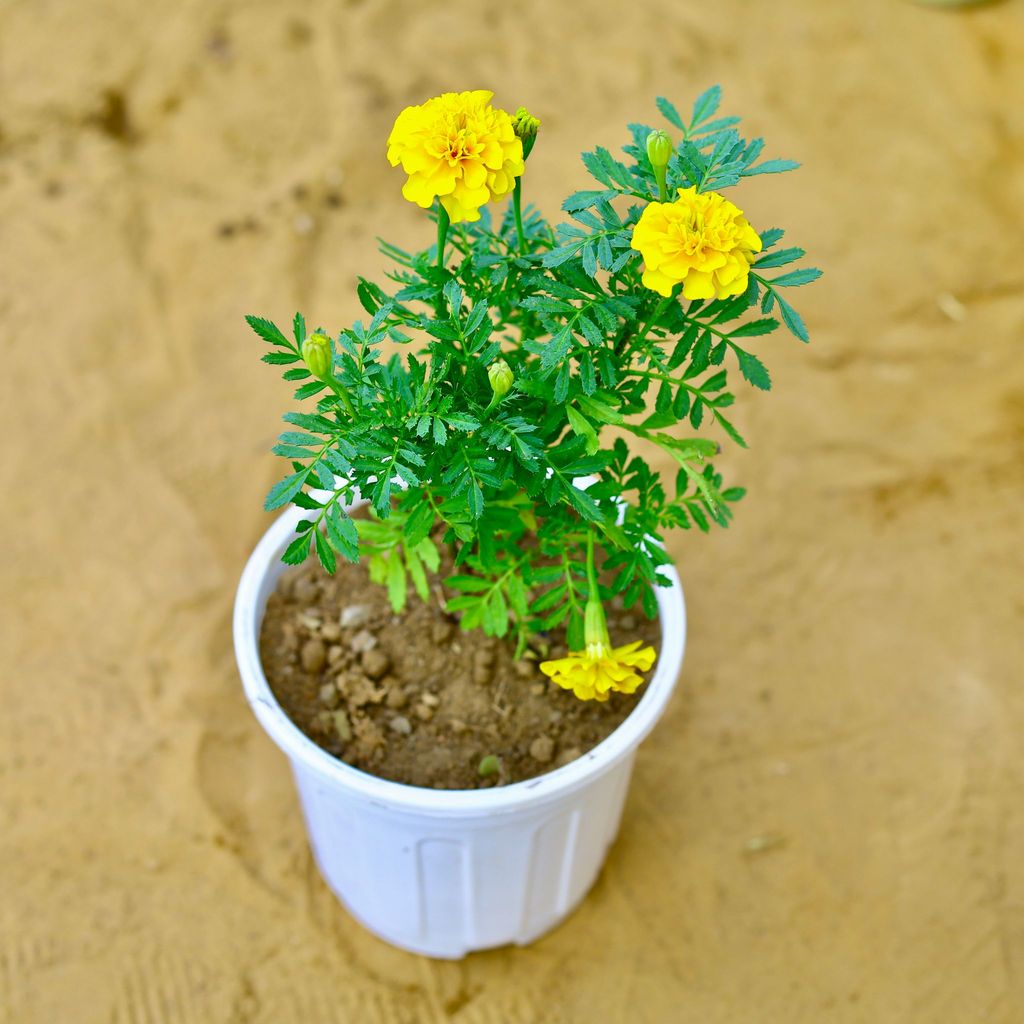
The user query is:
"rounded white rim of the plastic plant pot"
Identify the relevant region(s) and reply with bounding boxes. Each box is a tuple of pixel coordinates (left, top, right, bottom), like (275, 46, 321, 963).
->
(233, 502, 686, 817)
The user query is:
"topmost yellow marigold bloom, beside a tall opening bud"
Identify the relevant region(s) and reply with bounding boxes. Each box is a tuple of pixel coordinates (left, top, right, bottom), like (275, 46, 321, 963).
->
(387, 89, 523, 223)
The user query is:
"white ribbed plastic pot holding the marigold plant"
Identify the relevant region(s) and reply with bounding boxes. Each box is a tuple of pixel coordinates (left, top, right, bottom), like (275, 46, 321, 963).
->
(234, 499, 686, 958)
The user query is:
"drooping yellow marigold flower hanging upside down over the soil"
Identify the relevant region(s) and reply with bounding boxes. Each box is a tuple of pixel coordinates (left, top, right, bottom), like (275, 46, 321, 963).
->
(541, 593, 656, 700)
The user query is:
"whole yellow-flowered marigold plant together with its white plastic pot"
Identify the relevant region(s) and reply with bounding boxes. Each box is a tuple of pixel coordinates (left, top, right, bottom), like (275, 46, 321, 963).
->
(234, 87, 818, 956)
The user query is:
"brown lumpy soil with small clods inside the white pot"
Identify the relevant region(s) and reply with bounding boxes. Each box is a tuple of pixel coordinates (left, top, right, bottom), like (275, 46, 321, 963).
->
(254, 562, 659, 790)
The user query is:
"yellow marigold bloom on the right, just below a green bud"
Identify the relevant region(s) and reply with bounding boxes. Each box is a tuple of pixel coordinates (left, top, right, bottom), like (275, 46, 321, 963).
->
(632, 186, 761, 299)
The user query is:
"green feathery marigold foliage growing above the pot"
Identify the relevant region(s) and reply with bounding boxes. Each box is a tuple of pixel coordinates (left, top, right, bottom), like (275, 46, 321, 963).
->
(248, 86, 820, 649)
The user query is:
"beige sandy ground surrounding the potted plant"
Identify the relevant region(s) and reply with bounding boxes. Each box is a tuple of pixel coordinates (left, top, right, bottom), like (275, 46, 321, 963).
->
(0, 0, 1024, 1024)
